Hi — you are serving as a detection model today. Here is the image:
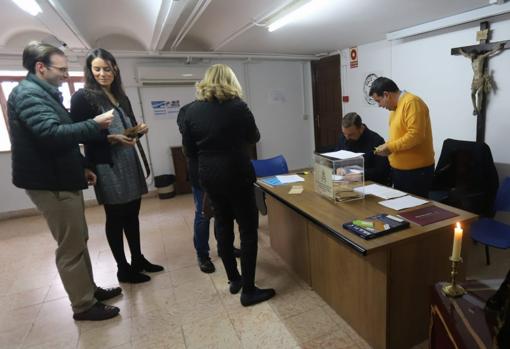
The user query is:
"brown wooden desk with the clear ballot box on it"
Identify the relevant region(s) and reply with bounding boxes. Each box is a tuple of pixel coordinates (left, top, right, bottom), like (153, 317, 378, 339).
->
(258, 174, 477, 349)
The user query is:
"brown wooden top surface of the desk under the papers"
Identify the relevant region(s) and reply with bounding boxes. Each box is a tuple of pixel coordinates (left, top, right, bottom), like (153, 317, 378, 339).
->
(257, 172, 477, 254)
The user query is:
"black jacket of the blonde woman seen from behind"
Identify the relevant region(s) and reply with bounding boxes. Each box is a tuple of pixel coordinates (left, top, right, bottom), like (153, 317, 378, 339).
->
(178, 98, 260, 191)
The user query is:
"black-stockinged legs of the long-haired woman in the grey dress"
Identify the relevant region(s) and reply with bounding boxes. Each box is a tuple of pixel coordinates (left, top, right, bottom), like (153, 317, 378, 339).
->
(104, 198, 142, 269)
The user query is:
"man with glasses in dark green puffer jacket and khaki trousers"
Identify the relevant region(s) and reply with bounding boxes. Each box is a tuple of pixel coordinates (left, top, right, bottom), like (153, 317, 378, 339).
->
(7, 42, 122, 320)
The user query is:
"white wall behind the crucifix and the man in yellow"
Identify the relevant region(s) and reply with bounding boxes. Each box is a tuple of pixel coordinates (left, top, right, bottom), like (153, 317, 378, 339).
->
(342, 15, 510, 177)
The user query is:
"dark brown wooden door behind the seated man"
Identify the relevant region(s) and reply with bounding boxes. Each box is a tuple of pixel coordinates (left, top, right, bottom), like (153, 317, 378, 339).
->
(312, 55, 342, 152)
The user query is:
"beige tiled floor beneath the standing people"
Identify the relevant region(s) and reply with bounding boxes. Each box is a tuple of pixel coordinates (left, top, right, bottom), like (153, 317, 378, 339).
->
(0, 195, 509, 349)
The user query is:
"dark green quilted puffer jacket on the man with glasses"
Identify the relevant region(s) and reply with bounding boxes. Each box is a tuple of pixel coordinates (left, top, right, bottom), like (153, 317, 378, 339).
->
(7, 73, 105, 191)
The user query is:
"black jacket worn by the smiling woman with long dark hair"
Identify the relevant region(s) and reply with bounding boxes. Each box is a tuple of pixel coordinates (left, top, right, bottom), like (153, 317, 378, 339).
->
(71, 89, 140, 165)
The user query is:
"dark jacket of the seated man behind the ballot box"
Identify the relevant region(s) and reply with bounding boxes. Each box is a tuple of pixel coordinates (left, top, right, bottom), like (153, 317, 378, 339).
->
(336, 124, 390, 185)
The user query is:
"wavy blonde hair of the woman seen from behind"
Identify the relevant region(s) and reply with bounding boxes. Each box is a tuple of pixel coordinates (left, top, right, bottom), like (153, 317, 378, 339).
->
(195, 64, 243, 102)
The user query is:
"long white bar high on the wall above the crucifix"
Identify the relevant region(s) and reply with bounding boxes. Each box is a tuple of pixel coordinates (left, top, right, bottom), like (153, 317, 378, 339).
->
(386, 2, 510, 41)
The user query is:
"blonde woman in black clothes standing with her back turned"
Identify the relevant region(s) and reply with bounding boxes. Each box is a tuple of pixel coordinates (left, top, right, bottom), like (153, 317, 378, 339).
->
(179, 64, 275, 306)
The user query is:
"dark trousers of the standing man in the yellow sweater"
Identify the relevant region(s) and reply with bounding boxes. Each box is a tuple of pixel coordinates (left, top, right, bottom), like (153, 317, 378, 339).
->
(391, 165, 434, 198)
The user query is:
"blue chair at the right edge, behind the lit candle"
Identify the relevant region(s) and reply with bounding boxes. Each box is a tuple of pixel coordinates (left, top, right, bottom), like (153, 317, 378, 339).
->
(471, 177, 510, 265)
